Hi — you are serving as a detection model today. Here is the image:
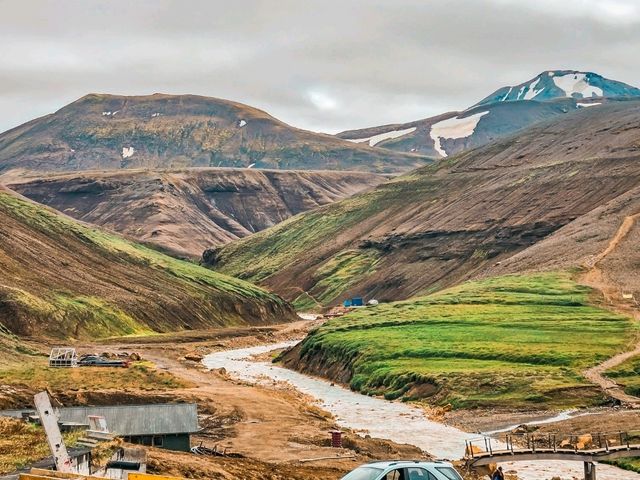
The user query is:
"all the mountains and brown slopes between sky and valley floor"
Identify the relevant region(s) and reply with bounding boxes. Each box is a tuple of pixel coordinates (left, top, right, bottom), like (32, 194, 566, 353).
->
(0, 71, 640, 348)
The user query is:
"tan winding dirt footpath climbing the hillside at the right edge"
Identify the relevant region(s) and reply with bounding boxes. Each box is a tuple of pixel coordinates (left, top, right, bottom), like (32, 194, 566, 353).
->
(582, 213, 640, 407)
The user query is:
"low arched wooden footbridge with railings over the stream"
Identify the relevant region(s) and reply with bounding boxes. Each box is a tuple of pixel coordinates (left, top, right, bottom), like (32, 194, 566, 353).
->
(465, 431, 640, 480)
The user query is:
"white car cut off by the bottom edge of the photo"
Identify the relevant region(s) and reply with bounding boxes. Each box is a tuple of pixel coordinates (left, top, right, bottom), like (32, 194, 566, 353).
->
(342, 460, 462, 480)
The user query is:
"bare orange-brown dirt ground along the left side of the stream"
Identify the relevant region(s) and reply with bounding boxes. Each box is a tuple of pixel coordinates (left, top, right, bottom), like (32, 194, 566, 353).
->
(86, 321, 425, 480)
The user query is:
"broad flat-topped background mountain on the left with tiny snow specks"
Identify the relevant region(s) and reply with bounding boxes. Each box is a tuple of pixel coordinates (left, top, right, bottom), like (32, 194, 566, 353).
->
(0, 94, 429, 172)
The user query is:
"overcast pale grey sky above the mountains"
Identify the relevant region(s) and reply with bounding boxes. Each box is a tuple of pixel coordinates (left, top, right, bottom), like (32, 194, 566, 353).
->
(0, 0, 640, 133)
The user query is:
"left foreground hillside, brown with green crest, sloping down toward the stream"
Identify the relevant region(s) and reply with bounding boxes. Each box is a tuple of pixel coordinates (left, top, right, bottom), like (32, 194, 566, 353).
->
(0, 189, 294, 344)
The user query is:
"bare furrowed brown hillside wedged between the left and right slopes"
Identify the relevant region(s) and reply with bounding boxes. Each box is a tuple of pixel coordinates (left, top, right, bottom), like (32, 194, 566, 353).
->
(5, 168, 385, 258)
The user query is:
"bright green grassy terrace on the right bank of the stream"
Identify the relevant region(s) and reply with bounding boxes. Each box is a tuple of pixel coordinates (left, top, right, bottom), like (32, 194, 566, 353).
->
(301, 273, 635, 408)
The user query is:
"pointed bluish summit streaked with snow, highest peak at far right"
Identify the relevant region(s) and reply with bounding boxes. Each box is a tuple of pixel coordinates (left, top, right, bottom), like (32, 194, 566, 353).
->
(476, 70, 640, 106)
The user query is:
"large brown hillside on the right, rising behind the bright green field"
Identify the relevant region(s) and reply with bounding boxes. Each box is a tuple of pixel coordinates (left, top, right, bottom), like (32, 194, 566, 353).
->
(205, 101, 640, 305)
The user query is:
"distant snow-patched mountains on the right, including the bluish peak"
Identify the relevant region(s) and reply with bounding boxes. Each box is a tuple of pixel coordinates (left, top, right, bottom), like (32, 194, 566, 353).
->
(337, 70, 640, 158)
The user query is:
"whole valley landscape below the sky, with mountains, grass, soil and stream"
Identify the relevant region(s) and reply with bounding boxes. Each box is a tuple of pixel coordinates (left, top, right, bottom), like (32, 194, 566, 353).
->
(0, 64, 640, 480)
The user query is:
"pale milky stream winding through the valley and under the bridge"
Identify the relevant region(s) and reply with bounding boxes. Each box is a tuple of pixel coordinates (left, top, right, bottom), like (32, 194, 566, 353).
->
(203, 342, 640, 480)
